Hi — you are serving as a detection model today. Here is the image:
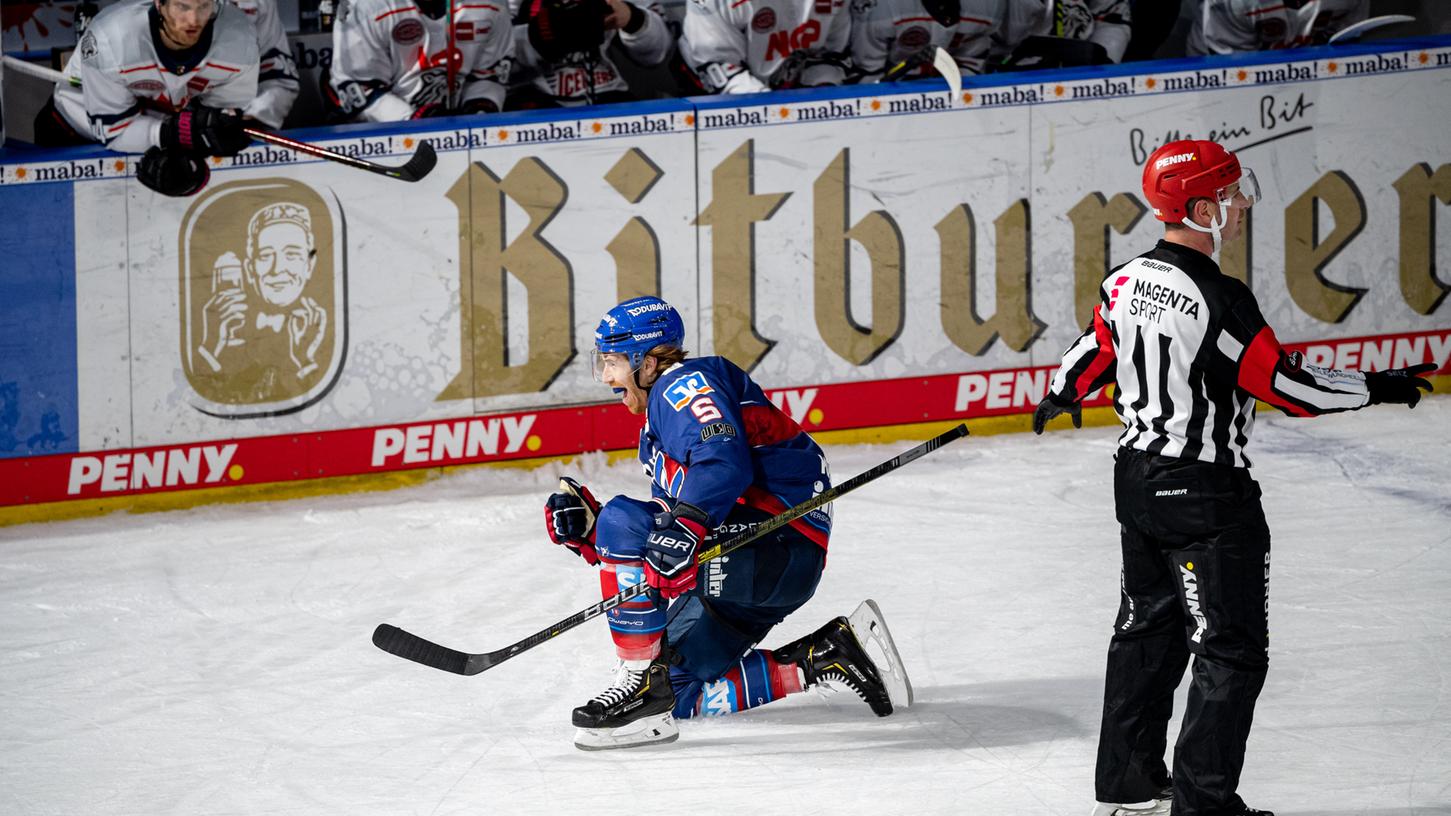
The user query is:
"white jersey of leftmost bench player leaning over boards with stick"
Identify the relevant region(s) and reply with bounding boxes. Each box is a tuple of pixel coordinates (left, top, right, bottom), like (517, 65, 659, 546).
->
(54, 0, 257, 152)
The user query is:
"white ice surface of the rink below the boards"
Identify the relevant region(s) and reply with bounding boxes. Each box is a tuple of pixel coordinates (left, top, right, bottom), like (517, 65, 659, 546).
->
(0, 396, 1451, 816)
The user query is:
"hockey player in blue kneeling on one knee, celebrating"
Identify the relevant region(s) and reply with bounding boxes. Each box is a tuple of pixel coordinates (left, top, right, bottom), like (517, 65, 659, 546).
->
(544, 296, 911, 751)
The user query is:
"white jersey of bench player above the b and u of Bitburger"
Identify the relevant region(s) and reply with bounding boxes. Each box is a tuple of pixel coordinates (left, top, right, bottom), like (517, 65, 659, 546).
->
(852, 0, 1008, 81)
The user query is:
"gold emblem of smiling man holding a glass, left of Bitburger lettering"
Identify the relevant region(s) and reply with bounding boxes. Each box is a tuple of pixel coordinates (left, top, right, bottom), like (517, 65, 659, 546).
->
(178, 179, 347, 418)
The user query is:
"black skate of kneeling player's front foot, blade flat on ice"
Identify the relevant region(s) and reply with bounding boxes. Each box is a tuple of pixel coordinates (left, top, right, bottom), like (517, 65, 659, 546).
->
(572, 661, 681, 751)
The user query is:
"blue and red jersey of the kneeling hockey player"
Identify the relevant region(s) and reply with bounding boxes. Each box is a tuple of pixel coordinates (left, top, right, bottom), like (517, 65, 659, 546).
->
(640, 357, 831, 549)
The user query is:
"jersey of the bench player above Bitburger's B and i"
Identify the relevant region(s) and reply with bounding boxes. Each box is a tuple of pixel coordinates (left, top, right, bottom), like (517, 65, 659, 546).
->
(514, 6, 675, 107)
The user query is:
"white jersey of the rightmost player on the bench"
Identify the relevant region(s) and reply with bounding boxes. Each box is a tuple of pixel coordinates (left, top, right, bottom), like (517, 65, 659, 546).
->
(1187, 0, 1370, 55)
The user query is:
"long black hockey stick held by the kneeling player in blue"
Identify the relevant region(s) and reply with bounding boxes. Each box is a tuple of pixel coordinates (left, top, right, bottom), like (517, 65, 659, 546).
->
(373, 424, 968, 675)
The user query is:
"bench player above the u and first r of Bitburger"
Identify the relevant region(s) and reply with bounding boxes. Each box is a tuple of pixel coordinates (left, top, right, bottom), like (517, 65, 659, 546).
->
(994, 0, 1133, 68)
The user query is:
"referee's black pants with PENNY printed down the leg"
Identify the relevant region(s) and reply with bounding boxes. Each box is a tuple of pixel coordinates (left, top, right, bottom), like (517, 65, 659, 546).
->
(1094, 447, 1270, 816)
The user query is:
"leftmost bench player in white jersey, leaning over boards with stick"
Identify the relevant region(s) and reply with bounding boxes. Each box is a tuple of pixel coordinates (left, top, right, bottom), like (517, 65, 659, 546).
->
(36, 0, 258, 155)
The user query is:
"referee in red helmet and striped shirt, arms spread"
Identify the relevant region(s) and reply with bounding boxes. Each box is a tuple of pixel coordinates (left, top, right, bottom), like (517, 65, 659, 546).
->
(1033, 141, 1436, 816)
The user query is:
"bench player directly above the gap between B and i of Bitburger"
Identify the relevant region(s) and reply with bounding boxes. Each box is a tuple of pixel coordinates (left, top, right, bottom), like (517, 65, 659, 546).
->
(508, 0, 675, 109)
